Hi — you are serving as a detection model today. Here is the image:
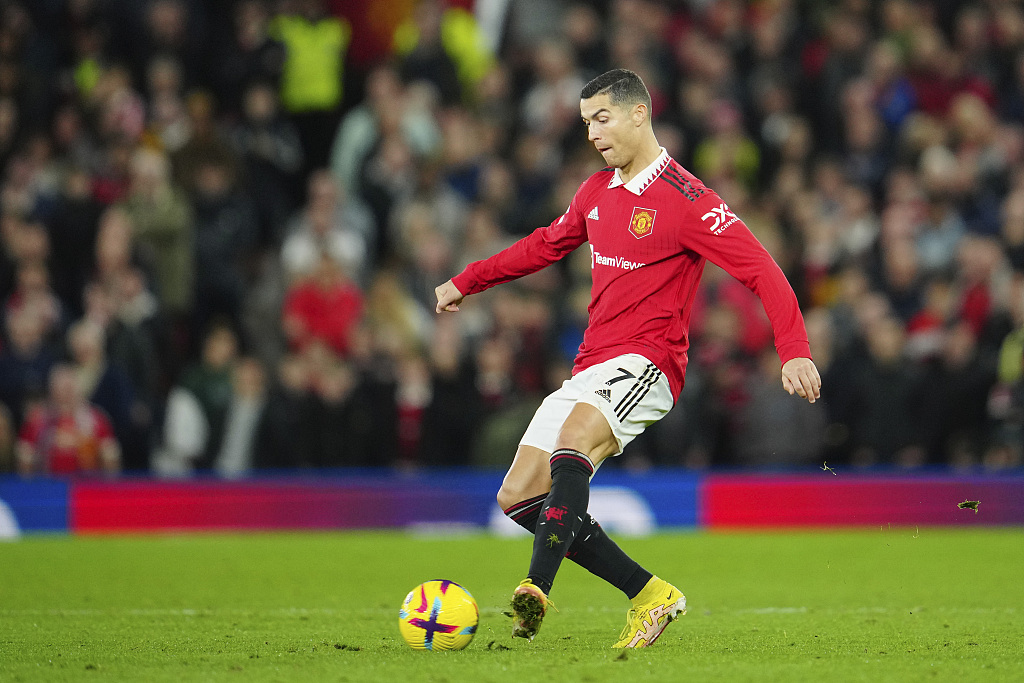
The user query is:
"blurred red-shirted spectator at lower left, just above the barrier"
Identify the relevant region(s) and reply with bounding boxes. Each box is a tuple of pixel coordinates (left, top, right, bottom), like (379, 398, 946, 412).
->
(17, 365, 121, 476)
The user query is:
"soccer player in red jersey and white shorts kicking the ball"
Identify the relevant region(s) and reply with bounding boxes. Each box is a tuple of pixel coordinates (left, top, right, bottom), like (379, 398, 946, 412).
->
(435, 69, 821, 647)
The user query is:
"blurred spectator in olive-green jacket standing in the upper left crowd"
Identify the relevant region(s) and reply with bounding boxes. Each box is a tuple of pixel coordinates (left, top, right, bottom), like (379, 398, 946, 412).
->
(117, 147, 196, 317)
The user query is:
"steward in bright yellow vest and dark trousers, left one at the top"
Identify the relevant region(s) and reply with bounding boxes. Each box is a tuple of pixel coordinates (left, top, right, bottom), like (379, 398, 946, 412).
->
(269, 0, 351, 173)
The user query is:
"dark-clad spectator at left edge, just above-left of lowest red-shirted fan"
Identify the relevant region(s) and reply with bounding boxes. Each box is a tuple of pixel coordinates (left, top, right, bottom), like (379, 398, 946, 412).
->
(0, 308, 56, 428)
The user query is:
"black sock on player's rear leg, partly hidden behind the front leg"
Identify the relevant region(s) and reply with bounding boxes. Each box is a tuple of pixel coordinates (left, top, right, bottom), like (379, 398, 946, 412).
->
(505, 494, 651, 600)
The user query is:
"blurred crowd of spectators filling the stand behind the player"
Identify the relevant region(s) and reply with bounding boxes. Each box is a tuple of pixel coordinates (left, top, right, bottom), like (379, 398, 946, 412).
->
(0, 0, 1024, 476)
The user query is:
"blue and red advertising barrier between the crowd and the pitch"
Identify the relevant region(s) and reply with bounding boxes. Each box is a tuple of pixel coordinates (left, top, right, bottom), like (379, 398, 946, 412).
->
(0, 469, 1024, 536)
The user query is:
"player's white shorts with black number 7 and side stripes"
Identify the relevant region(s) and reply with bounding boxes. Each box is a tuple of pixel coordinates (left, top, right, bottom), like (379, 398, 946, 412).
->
(519, 353, 673, 462)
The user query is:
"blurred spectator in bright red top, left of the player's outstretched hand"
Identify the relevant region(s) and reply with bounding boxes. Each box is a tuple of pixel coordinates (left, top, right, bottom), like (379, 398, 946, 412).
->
(284, 254, 364, 356)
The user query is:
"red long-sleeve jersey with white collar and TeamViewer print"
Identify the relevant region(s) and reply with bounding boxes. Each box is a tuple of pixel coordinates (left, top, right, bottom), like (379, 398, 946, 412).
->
(453, 150, 811, 398)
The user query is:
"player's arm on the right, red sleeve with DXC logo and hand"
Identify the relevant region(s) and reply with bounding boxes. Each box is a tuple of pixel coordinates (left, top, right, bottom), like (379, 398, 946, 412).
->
(680, 191, 821, 403)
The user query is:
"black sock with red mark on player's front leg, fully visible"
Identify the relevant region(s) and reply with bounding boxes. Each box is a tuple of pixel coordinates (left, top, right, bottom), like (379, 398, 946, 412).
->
(526, 449, 594, 593)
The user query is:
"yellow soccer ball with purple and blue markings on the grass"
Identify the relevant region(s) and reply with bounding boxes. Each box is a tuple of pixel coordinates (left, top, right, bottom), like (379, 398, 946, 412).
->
(398, 579, 480, 650)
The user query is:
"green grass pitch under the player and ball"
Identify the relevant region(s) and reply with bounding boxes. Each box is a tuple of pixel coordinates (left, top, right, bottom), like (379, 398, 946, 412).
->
(0, 527, 1024, 683)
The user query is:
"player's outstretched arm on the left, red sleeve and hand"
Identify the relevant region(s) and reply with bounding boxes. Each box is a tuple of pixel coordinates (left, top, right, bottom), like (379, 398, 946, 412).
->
(434, 188, 587, 313)
